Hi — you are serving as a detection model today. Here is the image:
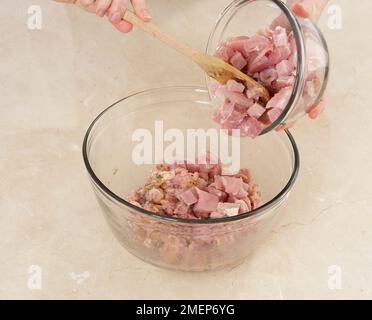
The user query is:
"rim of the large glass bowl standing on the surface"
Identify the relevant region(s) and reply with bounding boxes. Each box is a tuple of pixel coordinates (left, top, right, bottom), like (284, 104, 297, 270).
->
(82, 86, 300, 225)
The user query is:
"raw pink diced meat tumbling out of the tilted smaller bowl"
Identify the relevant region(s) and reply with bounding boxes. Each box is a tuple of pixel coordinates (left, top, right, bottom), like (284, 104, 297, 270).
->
(213, 26, 297, 137)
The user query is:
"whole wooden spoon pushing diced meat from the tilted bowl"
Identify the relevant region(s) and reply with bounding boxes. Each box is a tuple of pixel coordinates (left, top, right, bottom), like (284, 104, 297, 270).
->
(123, 10, 270, 104)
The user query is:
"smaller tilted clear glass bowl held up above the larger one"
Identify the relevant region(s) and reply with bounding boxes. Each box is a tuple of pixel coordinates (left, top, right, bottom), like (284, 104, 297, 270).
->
(207, 0, 329, 134)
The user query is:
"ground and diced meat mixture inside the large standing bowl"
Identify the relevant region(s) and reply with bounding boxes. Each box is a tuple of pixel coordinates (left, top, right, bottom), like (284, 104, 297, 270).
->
(129, 153, 261, 219)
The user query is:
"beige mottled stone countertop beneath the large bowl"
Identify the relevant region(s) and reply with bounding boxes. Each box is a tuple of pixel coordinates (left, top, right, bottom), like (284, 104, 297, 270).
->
(0, 0, 372, 299)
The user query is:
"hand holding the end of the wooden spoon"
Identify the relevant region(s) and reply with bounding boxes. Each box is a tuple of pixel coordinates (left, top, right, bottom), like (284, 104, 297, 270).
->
(55, 0, 151, 33)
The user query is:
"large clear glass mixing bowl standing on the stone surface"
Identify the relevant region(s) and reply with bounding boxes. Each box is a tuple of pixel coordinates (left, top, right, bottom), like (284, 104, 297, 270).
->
(83, 87, 299, 271)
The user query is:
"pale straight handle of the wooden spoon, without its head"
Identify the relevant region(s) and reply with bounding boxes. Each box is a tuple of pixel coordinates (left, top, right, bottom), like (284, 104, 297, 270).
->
(123, 10, 201, 61)
